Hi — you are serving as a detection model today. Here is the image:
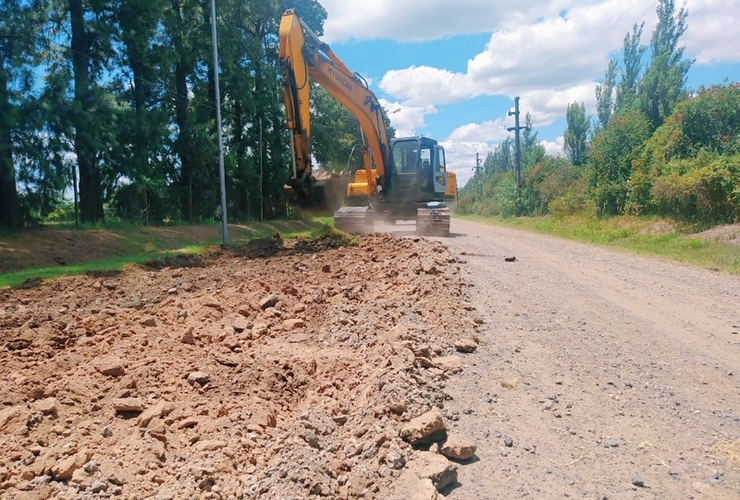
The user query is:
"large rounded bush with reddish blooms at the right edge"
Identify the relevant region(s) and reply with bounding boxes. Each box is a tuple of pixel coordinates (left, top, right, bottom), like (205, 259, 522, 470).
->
(627, 84, 740, 222)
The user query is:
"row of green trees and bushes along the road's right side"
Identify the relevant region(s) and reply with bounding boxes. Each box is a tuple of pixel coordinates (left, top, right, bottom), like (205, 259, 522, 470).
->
(460, 0, 740, 224)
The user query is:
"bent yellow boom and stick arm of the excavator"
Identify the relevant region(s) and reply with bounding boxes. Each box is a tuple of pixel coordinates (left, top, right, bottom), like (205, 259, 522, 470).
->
(278, 9, 391, 203)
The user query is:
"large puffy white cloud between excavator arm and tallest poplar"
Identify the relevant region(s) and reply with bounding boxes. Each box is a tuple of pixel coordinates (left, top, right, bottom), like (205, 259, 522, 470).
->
(370, 0, 654, 131)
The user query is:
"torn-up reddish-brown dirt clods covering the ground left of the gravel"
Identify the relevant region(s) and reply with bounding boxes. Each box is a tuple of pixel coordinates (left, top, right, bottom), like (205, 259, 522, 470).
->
(0, 235, 476, 499)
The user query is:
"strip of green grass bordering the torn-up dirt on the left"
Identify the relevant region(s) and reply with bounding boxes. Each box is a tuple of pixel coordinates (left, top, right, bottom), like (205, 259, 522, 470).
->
(0, 221, 322, 288)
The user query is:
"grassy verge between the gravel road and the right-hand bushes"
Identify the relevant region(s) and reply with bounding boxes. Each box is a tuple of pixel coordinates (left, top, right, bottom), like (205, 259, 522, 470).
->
(461, 216, 740, 274)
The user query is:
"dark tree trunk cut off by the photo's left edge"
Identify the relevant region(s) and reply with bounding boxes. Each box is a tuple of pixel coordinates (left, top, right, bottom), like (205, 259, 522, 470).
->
(0, 65, 21, 229)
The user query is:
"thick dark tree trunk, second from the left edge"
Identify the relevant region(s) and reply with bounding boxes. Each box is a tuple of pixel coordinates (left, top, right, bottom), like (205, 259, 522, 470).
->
(69, 0, 103, 223)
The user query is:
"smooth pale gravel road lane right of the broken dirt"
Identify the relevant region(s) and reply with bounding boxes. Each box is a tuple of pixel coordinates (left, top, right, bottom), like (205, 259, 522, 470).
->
(436, 219, 740, 500)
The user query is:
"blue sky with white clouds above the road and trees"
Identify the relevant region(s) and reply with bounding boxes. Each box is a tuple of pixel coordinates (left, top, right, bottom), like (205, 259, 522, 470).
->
(321, 0, 740, 185)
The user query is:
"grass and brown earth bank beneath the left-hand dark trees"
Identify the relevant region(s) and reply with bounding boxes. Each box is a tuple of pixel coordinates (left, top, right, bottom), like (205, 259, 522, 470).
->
(0, 221, 326, 288)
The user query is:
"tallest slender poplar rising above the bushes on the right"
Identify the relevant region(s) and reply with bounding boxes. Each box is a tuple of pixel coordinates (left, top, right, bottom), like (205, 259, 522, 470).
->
(639, 0, 694, 129)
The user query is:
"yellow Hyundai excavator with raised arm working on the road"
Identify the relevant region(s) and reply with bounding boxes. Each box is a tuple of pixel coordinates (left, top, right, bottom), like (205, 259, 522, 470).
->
(278, 9, 457, 236)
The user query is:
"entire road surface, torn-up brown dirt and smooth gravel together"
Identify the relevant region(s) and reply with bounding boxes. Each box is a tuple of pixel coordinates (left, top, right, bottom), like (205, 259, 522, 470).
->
(0, 220, 740, 500)
